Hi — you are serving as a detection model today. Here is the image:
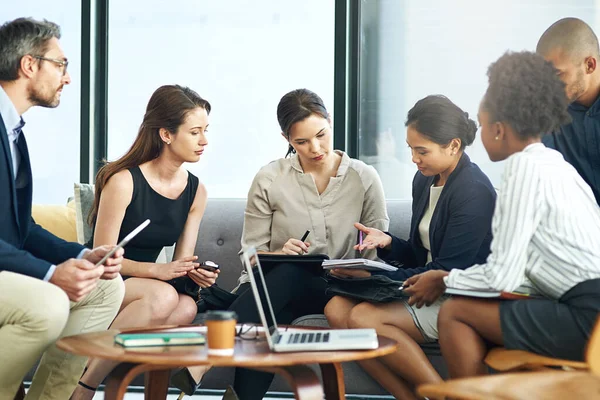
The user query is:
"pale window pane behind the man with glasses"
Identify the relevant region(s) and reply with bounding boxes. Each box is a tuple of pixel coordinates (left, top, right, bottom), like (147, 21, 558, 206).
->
(0, 0, 81, 204)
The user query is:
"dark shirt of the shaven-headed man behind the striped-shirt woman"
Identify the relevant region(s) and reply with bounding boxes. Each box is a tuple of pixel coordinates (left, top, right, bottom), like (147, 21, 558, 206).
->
(542, 97, 600, 205)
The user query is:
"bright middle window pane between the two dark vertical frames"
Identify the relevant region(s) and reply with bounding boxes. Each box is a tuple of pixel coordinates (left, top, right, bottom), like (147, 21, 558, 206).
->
(108, 0, 334, 197)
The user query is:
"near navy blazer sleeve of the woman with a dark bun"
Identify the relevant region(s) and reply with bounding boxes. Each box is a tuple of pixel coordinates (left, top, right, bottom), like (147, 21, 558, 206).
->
(386, 181, 496, 281)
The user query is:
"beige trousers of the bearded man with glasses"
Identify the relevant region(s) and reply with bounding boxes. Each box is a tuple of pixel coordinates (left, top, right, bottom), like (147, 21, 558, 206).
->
(0, 271, 125, 400)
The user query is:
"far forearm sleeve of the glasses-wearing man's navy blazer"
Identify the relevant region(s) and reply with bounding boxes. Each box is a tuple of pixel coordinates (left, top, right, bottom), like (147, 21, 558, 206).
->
(23, 218, 85, 268)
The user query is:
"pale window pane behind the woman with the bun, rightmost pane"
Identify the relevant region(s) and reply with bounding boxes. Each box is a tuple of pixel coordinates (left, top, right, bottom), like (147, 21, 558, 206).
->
(359, 0, 600, 199)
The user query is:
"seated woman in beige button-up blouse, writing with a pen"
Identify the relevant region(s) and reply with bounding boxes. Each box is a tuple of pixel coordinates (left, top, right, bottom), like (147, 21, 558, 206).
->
(230, 89, 389, 400)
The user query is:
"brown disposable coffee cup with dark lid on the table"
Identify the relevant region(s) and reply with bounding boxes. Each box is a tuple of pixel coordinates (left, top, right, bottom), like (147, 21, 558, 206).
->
(204, 311, 237, 356)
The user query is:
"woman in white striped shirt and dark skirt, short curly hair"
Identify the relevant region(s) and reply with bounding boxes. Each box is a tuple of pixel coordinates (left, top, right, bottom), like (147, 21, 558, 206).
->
(406, 52, 600, 378)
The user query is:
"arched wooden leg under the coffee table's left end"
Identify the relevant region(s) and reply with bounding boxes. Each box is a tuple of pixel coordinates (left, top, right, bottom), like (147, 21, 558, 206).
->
(104, 363, 170, 400)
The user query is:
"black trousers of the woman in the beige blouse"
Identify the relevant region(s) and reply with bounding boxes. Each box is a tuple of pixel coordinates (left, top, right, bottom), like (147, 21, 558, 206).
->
(229, 263, 329, 400)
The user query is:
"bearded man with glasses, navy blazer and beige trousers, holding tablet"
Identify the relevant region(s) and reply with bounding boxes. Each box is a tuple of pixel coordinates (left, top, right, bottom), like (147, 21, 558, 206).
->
(0, 18, 124, 399)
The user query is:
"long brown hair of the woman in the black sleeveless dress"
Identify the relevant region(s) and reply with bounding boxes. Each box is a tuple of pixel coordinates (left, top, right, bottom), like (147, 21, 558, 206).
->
(88, 85, 211, 225)
